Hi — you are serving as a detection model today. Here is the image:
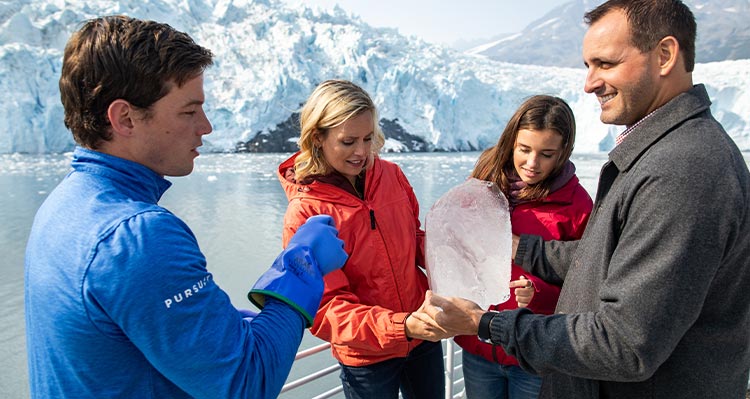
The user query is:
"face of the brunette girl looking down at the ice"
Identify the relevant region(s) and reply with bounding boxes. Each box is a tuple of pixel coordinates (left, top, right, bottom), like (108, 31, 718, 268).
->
(513, 129, 562, 185)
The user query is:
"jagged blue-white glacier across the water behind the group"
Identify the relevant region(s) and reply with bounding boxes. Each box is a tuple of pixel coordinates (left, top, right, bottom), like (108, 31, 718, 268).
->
(0, 0, 750, 153)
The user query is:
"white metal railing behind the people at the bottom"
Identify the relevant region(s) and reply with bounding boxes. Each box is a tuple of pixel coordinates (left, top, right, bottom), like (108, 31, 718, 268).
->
(281, 339, 464, 399)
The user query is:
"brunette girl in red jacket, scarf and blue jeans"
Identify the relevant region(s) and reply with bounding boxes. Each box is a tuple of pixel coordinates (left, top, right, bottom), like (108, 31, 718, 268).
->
(455, 95, 593, 399)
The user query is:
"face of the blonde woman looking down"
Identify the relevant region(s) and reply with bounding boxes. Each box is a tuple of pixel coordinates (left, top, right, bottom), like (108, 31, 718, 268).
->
(317, 111, 375, 184)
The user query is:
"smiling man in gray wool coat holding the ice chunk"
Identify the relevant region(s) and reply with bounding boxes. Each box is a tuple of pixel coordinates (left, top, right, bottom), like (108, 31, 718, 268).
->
(425, 0, 750, 398)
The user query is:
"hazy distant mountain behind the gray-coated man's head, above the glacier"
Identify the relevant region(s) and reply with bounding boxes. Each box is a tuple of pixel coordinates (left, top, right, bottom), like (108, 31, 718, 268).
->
(476, 0, 750, 68)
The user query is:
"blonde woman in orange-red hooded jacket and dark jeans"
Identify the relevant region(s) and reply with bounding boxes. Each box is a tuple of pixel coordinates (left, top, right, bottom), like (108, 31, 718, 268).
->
(279, 80, 445, 399)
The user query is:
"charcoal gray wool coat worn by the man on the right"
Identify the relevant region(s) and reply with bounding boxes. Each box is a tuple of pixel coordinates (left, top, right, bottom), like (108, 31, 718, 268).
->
(490, 85, 750, 399)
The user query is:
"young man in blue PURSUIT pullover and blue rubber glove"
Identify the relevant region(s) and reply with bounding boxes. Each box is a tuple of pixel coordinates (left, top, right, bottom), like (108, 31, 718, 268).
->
(25, 16, 347, 399)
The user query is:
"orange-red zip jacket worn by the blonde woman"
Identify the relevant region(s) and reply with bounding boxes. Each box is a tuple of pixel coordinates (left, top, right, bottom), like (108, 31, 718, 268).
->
(278, 154, 428, 366)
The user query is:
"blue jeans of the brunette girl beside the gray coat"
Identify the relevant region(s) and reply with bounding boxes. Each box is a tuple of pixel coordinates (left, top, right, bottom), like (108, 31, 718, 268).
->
(462, 352, 542, 399)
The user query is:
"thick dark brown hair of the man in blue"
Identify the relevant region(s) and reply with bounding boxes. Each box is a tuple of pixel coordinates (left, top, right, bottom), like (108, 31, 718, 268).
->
(60, 15, 213, 149)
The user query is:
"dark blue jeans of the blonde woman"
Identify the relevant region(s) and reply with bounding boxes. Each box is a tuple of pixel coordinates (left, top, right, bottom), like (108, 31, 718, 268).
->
(340, 341, 445, 399)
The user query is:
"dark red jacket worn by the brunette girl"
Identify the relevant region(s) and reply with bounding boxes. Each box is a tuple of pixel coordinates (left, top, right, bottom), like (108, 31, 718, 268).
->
(454, 176, 593, 365)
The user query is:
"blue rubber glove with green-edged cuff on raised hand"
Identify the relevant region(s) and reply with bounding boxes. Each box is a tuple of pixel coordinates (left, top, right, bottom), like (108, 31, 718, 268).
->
(247, 215, 349, 327)
